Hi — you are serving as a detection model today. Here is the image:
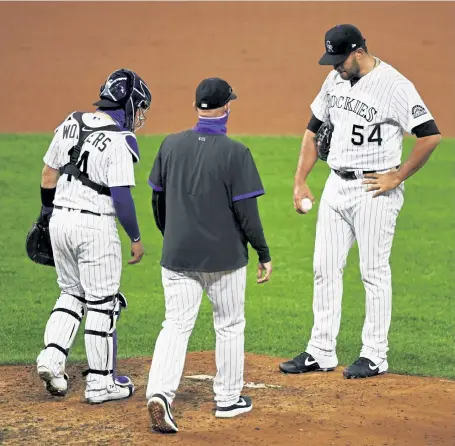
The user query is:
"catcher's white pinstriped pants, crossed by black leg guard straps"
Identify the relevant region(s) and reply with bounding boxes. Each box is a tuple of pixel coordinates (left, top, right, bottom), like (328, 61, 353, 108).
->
(37, 209, 122, 396)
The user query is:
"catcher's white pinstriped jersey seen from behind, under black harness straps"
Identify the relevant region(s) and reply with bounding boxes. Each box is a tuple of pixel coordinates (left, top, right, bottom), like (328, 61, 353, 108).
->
(43, 113, 138, 215)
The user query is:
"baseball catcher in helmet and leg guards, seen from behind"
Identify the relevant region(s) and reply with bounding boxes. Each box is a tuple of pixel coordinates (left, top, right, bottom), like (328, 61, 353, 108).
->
(30, 69, 152, 404)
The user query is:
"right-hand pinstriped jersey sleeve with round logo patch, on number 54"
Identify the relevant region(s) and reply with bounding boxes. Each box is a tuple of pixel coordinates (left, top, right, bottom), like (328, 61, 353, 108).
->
(390, 82, 433, 133)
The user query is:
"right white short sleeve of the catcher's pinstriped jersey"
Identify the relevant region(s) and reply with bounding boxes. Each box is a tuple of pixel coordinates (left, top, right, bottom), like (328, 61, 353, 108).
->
(107, 139, 136, 187)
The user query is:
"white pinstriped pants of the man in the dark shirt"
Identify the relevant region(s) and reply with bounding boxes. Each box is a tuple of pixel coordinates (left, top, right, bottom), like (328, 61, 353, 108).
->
(146, 266, 246, 407)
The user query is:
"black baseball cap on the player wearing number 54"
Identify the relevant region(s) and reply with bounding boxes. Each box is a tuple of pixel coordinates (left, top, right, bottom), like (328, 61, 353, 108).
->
(319, 24, 365, 65)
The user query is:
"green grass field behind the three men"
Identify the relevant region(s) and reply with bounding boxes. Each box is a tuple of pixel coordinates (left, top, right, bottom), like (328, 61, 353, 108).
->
(0, 135, 455, 378)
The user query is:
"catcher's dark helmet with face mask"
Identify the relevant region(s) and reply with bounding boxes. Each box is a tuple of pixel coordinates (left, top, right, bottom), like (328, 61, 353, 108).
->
(93, 68, 152, 132)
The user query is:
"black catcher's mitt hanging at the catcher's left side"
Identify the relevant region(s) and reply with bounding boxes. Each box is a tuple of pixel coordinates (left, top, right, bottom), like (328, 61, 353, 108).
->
(25, 213, 55, 266)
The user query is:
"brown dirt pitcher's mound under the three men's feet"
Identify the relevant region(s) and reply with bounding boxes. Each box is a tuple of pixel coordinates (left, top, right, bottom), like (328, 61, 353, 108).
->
(0, 352, 455, 446)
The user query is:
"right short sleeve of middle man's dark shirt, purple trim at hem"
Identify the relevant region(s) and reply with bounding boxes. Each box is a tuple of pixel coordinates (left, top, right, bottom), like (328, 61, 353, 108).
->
(230, 147, 265, 202)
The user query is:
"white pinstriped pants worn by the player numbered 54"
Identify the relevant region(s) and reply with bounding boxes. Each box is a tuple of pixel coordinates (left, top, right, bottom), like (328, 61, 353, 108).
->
(306, 172, 404, 367)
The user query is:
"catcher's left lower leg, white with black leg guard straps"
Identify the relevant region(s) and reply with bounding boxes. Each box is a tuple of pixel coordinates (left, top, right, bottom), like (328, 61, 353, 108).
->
(36, 292, 86, 377)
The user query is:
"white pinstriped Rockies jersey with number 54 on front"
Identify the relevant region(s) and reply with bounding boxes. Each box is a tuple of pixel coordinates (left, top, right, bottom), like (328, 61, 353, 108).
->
(311, 61, 433, 170)
